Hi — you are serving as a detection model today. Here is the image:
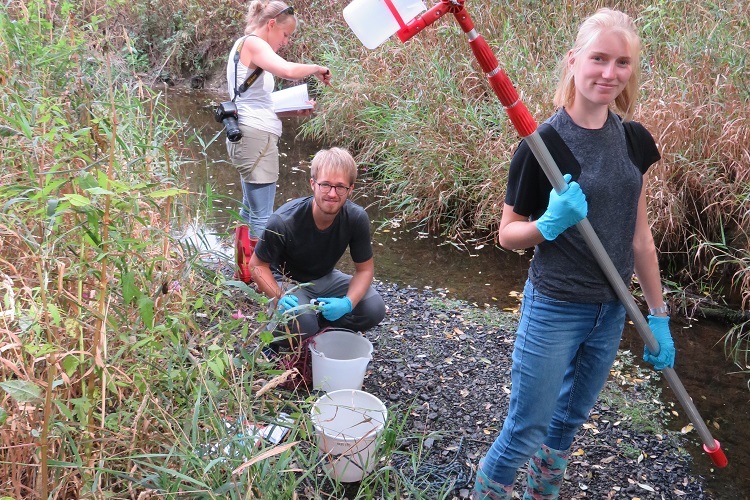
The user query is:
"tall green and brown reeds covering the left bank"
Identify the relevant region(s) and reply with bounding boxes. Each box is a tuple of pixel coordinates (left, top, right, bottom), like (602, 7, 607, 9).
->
(0, 1, 280, 492)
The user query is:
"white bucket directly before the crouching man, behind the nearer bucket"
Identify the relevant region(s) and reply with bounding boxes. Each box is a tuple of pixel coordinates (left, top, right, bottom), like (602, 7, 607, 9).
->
(310, 330, 372, 392)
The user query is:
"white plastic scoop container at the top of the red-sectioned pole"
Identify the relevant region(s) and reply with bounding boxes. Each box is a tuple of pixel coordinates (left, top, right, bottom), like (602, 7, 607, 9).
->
(344, 0, 427, 49)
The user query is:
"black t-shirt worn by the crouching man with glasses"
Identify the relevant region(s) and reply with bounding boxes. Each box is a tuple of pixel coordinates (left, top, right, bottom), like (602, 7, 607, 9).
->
(255, 196, 372, 283)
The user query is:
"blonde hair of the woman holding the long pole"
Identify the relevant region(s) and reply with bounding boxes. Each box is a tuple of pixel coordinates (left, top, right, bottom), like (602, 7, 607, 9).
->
(553, 9, 641, 120)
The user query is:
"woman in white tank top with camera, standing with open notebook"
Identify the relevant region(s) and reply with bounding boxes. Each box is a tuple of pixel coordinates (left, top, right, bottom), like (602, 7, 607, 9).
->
(227, 0, 331, 283)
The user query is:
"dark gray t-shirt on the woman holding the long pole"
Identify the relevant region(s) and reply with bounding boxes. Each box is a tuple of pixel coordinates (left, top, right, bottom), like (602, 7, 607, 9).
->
(506, 109, 658, 303)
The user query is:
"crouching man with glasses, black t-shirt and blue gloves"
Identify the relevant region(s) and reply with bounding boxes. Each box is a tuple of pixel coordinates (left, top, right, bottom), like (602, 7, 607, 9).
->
(250, 148, 385, 342)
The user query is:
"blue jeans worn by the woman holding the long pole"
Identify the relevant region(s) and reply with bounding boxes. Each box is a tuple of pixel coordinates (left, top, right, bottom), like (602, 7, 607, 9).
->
(482, 281, 625, 484)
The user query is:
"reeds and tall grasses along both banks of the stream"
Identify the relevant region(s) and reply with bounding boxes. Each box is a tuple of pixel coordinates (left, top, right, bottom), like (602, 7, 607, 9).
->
(0, 0, 750, 498)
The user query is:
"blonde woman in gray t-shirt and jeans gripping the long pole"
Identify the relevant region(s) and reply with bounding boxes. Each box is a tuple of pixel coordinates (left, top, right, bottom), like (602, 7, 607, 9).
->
(474, 9, 675, 499)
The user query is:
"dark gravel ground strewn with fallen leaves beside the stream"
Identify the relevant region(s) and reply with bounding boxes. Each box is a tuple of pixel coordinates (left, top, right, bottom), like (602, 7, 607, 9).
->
(356, 284, 712, 499)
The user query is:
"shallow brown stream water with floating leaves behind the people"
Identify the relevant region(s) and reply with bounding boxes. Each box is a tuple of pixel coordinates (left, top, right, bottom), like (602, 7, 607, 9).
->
(167, 91, 750, 499)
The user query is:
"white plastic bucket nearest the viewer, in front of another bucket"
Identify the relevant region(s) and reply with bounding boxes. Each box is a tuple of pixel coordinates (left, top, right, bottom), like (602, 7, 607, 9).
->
(310, 389, 388, 483)
